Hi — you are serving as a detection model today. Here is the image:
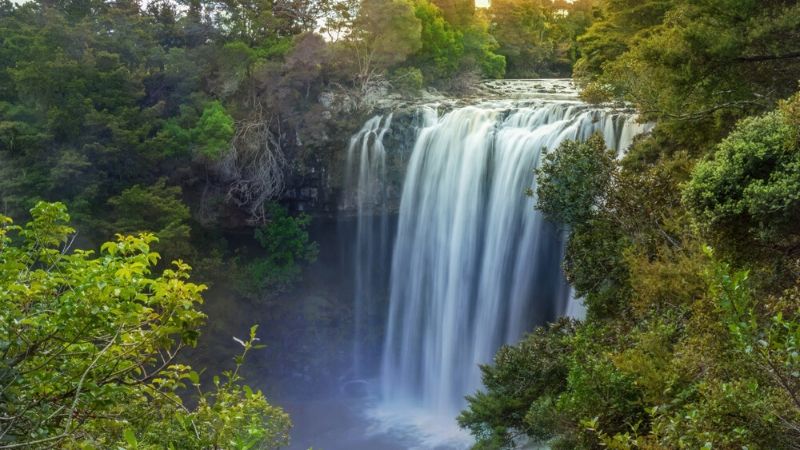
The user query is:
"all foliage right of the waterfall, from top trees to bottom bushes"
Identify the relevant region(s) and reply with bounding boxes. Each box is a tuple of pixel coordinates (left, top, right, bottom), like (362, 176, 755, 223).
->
(461, 0, 800, 450)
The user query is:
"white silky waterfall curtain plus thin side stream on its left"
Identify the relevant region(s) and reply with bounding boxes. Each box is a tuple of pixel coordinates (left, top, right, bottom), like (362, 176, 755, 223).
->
(350, 88, 647, 445)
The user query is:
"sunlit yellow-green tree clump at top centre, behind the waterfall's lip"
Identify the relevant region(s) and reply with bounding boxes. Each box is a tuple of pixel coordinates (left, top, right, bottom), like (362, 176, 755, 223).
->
(334, 0, 505, 88)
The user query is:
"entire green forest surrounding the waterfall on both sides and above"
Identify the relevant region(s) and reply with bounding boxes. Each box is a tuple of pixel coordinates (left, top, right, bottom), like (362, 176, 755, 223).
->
(0, 0, 800, 450)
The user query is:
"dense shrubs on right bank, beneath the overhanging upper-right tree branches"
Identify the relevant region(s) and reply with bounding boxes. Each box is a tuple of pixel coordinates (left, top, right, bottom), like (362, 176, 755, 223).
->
(461, 83, 800, 450)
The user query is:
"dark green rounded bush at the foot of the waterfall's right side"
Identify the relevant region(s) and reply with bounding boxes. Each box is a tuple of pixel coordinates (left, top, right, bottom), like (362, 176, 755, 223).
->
(459, 319, 645, 448)
